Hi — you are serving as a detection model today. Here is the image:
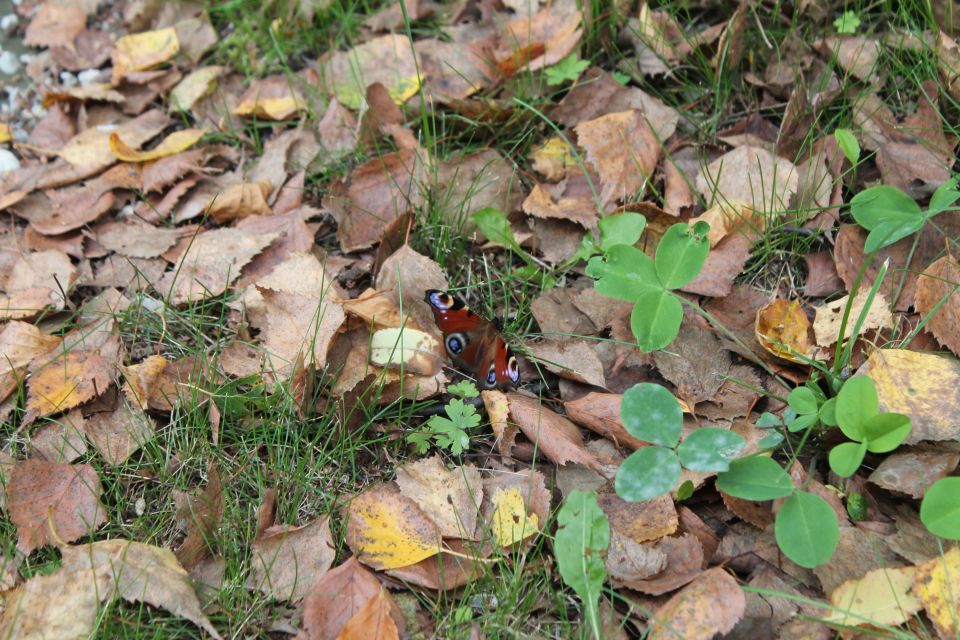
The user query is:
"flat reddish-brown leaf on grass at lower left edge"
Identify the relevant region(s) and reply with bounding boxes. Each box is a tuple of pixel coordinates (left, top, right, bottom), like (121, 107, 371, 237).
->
(6, 459, 107, 555)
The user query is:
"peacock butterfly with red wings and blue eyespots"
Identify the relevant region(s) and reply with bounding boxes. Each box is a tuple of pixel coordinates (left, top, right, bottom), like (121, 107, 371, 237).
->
(426, 289, 520, 389)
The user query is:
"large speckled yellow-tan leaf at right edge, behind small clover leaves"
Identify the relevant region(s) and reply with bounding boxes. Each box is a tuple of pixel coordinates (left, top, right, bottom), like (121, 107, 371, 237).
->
(860, 349, 960, 444)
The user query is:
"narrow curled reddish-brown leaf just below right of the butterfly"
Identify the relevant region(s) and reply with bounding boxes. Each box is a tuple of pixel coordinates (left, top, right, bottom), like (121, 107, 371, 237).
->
(507, 393, 600, 470)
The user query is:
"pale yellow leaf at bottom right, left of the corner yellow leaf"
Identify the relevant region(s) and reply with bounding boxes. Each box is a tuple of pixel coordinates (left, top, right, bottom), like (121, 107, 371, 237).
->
(827, 567, 920, 626)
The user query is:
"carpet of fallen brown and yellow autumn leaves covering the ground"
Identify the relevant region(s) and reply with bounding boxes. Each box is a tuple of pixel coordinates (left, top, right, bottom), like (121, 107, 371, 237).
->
(0, 0, 960, 638)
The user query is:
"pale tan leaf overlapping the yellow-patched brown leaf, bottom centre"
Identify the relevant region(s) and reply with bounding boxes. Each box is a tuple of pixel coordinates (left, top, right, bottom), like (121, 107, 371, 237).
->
(396, 455, 483, 539)
